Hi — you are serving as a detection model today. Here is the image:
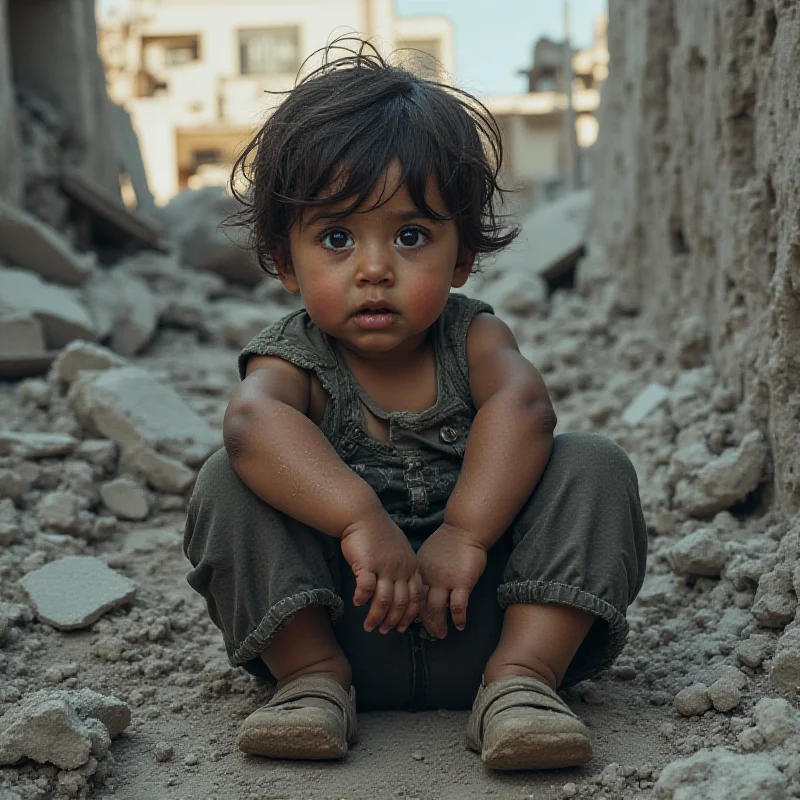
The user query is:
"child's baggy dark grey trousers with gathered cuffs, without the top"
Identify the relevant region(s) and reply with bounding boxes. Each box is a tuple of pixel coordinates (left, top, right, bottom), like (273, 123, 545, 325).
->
(184, 433, 647, 709)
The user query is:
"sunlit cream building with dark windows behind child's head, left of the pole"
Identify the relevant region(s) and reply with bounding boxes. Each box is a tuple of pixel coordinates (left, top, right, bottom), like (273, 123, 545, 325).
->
(98, 0, 455, 203)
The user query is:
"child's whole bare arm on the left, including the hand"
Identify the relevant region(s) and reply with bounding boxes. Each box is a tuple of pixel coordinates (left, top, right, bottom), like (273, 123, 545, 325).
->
(223, 356, 422, 632)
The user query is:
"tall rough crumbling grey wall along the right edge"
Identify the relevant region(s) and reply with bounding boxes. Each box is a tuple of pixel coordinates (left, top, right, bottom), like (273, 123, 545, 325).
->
(592, 0, 800, 513)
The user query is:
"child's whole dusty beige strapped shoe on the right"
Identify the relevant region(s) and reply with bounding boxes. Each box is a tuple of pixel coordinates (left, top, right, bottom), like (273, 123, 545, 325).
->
(467, 676, 592, 769)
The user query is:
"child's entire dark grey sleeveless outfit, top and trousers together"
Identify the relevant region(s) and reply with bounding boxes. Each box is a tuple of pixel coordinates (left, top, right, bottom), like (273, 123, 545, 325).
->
(184, 294, 647, 709)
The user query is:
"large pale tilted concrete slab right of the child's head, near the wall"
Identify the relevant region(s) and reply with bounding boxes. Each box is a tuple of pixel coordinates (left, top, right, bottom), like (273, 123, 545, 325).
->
(495, 189, 592, 281)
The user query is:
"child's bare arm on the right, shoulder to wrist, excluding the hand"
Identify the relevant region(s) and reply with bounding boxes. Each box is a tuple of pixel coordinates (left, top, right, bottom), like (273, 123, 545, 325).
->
(445, 314, 556, 549)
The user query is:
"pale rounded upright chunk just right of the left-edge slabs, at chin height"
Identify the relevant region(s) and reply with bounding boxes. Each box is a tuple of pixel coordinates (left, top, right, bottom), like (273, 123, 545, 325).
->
(86, 271, 158, 356)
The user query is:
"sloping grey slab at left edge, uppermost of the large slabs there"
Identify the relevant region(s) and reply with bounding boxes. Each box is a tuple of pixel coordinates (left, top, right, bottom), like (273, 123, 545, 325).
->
(0, 200, 96, 286)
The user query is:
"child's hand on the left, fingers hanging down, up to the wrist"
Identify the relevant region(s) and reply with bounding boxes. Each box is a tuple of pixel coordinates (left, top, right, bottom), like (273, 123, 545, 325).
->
(341, 509, 422, 633)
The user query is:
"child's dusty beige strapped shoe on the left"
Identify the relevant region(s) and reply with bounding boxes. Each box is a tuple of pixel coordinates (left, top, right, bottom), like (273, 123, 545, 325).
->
(237, 675, 358, 760)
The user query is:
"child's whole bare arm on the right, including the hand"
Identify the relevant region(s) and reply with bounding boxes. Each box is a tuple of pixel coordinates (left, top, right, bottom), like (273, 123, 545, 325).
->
(417, 314, 556, 638)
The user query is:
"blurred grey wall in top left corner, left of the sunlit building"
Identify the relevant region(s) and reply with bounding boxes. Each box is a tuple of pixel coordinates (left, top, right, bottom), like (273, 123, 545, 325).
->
(7, 0, 119, 194)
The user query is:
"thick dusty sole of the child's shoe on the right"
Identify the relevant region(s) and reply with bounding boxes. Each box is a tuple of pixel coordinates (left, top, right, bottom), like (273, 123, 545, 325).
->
(481, 733, 592, 770)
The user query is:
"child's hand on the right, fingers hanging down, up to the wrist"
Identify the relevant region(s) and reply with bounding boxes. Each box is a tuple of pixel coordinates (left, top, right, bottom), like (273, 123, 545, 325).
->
(417, 523, 486, 639)
